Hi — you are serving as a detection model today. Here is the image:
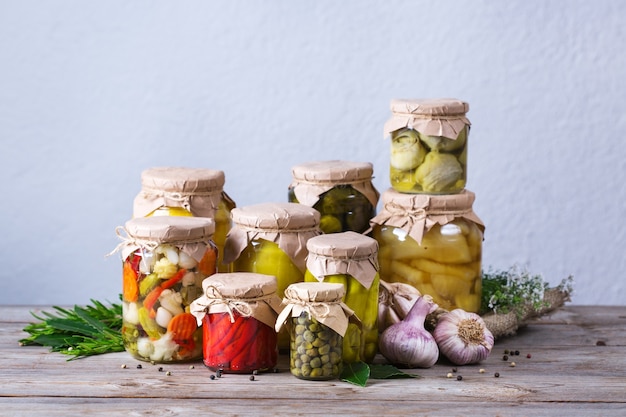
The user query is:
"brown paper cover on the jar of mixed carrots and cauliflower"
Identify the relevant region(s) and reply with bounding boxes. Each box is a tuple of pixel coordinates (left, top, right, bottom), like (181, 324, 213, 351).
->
(115, 216, 215, 262)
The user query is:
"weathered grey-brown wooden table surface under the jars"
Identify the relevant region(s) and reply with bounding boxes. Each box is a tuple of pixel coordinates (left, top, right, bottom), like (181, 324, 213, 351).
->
(0, 306, 626, 417)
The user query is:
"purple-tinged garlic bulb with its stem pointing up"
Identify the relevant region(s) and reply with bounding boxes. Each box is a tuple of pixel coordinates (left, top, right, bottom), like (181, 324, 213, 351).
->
(378, 295, 439, 368)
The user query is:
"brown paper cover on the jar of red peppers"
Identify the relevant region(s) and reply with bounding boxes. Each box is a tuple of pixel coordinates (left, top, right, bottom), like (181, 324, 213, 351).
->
(190, 272, 283, 328)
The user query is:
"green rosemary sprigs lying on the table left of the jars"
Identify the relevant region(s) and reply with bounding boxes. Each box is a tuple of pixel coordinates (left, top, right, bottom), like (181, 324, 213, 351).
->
(19, 300, 124, 360)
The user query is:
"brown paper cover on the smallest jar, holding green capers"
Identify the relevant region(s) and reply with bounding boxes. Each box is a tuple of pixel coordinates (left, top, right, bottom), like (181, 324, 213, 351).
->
(276, 282, 357, 337)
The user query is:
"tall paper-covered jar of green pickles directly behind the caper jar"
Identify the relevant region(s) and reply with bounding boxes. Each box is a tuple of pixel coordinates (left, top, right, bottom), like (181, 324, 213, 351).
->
(304, 232, 380, 363)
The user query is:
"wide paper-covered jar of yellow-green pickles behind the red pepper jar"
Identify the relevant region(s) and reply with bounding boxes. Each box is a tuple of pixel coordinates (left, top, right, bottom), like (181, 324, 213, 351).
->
(224, 203, 322, 350)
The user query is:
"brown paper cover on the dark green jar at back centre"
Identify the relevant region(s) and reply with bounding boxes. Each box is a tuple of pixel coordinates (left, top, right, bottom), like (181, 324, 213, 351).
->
(289, 160, 380, 207)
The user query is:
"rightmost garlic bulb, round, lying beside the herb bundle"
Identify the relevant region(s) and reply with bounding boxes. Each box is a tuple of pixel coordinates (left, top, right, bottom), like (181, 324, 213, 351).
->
(433, 308, 494, 365)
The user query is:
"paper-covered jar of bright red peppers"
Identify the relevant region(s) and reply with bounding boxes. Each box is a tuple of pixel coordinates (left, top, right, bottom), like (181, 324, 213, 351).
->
(191, 273, 282, 373)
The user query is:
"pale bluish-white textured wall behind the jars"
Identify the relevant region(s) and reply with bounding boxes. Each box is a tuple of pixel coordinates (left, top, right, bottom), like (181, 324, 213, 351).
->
(0, 0, 626, 304)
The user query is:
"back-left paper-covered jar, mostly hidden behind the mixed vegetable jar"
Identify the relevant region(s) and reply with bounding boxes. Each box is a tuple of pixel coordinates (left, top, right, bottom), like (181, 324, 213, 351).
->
(133, 167, 236, 272)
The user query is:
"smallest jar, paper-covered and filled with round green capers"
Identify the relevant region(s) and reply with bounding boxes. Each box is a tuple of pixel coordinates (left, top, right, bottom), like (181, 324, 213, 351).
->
(276, 282, 354, 380)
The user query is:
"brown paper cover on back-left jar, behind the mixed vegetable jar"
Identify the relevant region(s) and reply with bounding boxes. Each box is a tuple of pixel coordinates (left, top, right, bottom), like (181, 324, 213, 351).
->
(133, 167, 235, 217)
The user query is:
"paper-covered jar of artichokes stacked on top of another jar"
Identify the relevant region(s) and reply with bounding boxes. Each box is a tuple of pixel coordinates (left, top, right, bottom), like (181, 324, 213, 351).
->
(384, 99, 470, 194)
